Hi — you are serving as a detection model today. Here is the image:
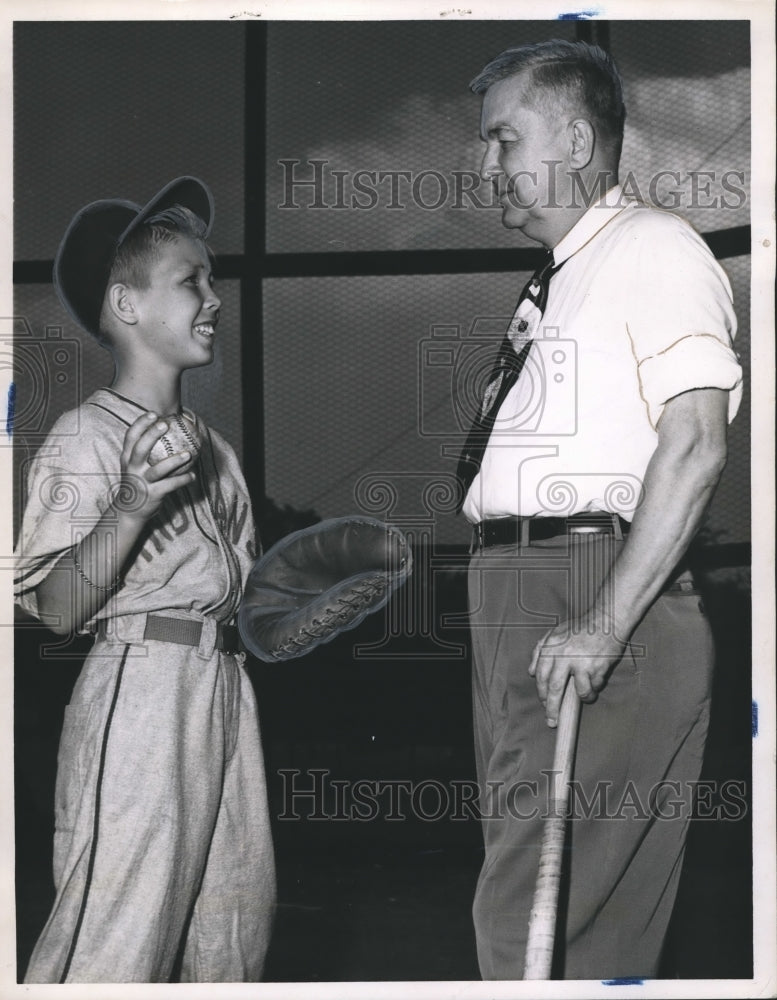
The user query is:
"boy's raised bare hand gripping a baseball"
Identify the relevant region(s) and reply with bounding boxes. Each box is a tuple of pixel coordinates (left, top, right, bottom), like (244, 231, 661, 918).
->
(115, 413, 195, 521)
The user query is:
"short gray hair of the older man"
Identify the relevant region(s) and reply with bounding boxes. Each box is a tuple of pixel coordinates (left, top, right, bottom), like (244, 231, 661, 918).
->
(470, 38, 626, 157)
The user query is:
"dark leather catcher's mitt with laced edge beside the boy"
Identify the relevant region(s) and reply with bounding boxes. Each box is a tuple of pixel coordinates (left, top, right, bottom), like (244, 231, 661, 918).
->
(237, 516, 412, 663)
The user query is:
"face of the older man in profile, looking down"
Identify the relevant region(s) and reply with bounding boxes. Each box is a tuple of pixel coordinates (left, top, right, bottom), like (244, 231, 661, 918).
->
(480, 73, 569, 246)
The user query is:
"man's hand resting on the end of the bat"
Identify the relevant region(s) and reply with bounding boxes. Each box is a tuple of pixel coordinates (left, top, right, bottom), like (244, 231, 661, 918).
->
(529, 614, 627, 728)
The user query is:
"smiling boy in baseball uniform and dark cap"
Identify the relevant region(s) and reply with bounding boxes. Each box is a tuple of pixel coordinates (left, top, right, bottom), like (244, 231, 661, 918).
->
(15, 177, 275, 983)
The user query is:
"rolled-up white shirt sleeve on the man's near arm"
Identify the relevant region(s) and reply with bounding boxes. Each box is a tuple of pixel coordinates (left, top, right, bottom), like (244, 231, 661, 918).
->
(626, 213, 742, 428)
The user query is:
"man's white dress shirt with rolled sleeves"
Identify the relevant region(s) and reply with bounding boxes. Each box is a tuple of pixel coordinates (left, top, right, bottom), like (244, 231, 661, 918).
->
(463, 186, 742, 522)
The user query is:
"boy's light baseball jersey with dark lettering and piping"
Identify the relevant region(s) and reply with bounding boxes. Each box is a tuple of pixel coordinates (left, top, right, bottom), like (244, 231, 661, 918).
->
(14, 389, 255, 621)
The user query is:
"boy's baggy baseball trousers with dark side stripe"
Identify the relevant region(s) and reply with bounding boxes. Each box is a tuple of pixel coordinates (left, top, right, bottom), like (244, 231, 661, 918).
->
(26, 640, 275, 983)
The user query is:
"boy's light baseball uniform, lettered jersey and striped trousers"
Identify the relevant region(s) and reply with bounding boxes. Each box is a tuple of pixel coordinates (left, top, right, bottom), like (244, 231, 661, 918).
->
(15, 389, 275, 982)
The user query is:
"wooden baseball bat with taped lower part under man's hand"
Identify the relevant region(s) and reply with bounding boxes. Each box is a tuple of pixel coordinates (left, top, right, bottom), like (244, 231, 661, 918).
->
(523, 677, 580, 979)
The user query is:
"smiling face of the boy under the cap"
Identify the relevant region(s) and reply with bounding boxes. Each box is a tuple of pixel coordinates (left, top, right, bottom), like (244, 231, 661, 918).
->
(133, 236, 221, 374)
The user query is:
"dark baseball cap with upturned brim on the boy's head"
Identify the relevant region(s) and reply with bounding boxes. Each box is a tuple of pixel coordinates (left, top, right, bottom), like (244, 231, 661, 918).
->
(54, 177, 214, 336)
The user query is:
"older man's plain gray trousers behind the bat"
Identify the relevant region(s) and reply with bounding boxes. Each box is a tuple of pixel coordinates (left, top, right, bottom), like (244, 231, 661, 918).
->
(469, 535, 713, 979)
